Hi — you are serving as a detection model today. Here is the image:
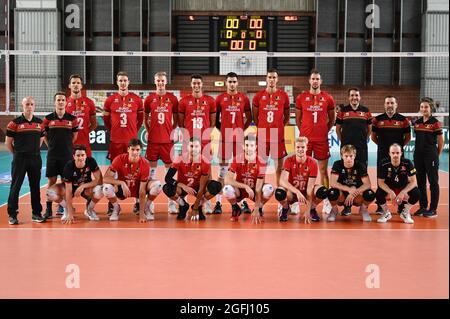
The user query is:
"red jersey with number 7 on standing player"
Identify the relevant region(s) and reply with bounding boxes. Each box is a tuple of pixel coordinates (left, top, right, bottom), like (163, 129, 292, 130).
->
(216, 92, 250, 142)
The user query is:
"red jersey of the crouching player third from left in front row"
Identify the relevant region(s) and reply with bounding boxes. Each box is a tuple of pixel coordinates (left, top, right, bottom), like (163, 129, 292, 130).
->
(172, 156, 211, 190)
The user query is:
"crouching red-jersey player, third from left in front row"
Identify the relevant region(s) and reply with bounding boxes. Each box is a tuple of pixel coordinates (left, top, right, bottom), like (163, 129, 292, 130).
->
(163, 137, 222, 220)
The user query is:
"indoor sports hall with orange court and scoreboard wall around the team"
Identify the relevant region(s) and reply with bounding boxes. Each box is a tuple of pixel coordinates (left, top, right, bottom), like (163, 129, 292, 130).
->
(0, 0, 449, 299)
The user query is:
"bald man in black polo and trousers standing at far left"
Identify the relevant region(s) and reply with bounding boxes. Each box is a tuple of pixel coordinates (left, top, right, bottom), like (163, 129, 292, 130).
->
(5, 96, 45, 225)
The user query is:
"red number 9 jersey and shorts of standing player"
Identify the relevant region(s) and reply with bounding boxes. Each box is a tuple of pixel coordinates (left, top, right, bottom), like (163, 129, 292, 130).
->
(144, 92, 178, 164)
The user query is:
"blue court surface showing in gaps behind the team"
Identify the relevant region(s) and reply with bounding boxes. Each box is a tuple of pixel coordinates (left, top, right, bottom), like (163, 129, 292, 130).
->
(0, 151, 449, 205)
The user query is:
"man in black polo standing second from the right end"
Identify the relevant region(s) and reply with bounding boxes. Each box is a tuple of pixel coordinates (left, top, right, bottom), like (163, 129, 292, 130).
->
(371, 95, 411, 214)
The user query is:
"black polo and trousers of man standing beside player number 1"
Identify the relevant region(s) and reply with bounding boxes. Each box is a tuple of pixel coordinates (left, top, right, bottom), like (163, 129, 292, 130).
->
(336, 104, 372, 166)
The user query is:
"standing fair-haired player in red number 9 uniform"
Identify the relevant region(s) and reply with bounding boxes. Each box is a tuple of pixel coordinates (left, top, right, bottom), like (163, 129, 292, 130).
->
(144, 72, 178, 213)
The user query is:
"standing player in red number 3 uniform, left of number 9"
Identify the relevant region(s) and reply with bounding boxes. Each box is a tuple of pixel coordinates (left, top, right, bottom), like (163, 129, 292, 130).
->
(103, 71, 144, 212)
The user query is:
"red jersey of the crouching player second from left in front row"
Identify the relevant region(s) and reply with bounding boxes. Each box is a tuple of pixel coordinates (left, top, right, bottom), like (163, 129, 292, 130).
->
(109, 154, 150, 197)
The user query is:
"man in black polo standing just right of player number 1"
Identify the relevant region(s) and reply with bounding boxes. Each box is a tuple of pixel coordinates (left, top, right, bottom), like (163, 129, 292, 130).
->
(336, 87, 372, 216)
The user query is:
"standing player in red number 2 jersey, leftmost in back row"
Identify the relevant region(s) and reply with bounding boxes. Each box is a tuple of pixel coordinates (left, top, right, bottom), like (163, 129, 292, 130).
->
(66, 74, 97, 157)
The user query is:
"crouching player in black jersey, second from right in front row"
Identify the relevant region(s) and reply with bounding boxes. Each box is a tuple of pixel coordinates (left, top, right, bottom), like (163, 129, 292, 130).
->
(327, 145, 375, 222)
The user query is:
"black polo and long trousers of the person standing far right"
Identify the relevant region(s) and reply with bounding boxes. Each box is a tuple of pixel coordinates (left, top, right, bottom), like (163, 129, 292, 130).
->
(414, 116, 442, 211)
